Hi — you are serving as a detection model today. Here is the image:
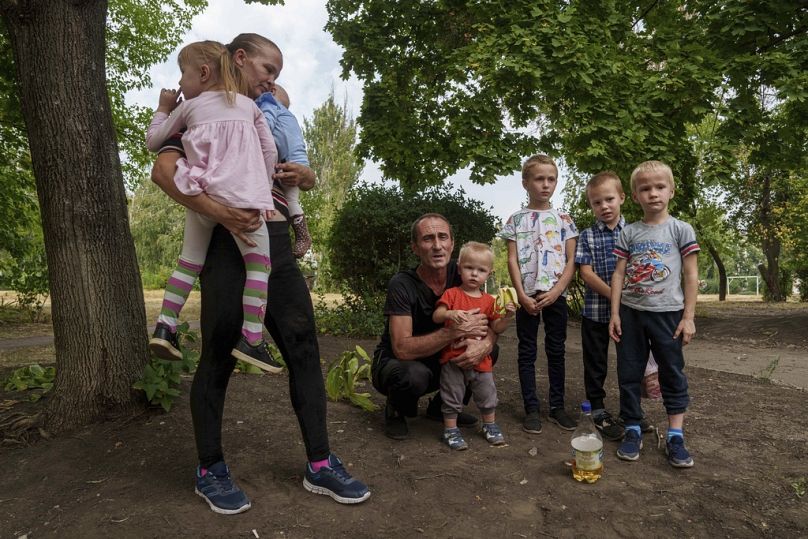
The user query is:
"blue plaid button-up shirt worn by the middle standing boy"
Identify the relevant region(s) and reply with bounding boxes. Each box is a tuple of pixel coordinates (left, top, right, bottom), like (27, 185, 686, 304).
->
(575, 215, 626, 324)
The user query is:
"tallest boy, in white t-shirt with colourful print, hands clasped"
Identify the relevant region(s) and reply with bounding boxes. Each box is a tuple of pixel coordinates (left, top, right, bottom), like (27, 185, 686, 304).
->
(500, 155, 578, 434)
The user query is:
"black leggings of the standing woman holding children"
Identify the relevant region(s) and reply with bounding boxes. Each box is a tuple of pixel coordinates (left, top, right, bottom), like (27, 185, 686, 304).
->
(191, 222, 330, 467)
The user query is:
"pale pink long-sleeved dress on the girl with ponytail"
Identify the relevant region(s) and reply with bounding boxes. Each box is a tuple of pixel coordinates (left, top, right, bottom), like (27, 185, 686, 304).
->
(146, 92, 278, 210)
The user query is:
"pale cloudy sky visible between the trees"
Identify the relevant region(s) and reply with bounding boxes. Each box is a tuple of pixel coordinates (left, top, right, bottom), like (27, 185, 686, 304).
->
(126, 0, 564, 222)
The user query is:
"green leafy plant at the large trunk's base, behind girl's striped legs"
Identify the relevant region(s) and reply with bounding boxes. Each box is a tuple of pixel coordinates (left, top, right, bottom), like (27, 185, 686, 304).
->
(132, 322, 199, 412)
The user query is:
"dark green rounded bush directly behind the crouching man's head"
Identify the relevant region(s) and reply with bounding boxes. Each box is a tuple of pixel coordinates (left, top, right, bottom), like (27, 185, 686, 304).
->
(329, 184, 496, 295)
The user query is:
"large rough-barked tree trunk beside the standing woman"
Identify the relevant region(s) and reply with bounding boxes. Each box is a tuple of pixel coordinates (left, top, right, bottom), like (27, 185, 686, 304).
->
(0, 0, 148, 431)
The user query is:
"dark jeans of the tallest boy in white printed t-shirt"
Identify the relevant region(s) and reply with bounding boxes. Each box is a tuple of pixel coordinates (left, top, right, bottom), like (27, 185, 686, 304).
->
(516, 296, 568, 413)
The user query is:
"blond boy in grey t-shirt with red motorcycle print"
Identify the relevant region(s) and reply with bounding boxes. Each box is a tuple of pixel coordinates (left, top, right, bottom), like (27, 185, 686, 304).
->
(609, 161, 700, 468)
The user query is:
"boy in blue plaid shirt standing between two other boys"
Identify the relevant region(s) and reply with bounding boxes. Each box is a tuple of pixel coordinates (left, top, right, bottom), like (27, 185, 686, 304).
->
(575, 171, 626, 440)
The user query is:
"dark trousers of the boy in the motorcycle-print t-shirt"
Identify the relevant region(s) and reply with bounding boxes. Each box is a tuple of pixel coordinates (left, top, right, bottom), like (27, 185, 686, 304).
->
(617, 305, 690, 425)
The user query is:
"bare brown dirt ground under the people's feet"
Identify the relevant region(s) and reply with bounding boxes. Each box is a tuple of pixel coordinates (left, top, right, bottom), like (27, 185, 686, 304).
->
(0, 303, 808, 539)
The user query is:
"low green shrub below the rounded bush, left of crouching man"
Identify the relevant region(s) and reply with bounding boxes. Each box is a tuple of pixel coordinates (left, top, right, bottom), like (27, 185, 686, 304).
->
(314, 289, 385, 337)
